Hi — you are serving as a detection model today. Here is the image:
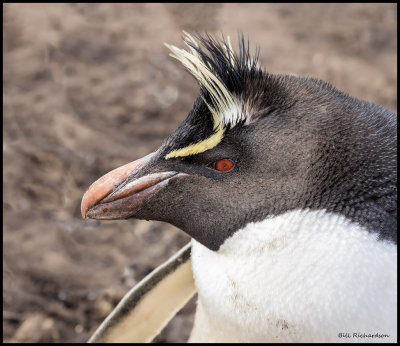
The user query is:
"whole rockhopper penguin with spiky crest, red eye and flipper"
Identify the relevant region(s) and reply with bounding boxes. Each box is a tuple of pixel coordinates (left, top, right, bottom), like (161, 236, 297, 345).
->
(82, 33, 397, 342)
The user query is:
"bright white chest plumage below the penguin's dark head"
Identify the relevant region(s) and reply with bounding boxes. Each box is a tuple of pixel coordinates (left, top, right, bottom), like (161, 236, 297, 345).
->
(191, 211, 397, 342)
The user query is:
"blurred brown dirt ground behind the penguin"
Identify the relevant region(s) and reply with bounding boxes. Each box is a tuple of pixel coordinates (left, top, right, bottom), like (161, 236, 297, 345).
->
(3, 3, 397, 342)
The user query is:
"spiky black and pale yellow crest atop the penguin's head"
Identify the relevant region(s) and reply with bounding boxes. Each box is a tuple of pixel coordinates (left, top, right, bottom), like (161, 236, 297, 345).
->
(163, 34, 290, 157)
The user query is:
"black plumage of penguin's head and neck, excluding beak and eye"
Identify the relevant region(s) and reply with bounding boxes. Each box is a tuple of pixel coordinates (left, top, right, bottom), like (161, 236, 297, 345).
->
(83, 35, 397, 250)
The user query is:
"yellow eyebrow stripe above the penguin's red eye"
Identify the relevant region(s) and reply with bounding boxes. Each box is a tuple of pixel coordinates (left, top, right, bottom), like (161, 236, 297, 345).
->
(165, 112, 225, 160)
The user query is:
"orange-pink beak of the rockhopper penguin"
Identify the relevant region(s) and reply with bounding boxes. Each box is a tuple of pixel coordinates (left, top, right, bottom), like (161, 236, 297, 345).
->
(81, 153, 178, 220)
